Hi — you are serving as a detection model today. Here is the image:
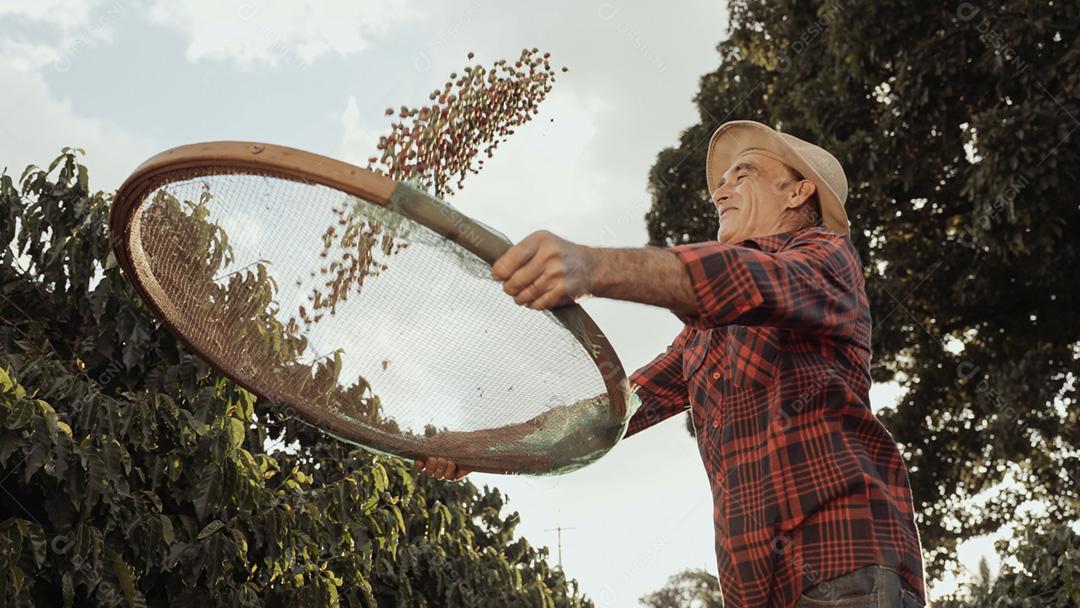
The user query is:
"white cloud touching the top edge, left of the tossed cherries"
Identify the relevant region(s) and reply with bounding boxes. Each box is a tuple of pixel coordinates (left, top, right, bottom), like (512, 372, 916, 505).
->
(150, 0, 417, 67)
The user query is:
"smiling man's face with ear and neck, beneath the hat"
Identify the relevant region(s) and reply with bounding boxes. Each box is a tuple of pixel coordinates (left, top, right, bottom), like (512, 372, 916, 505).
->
(713, 152, 814, 243)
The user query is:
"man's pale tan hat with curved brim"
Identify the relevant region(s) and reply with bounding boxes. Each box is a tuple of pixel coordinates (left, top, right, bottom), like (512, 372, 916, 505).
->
(705, 120, 850, 234)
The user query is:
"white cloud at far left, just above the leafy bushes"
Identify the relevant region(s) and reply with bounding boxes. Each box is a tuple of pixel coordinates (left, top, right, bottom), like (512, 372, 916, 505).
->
(0, 64, 153, 190)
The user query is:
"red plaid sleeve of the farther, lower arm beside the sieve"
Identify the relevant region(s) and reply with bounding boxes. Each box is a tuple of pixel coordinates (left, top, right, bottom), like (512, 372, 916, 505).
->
(623, 327, 690, 438)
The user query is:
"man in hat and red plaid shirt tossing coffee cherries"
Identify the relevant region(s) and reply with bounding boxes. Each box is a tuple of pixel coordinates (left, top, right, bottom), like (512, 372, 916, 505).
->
(417, 121, 926, 608)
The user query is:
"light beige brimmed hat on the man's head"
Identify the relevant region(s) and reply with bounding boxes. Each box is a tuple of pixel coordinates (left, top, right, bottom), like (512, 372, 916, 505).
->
(705, 120, 849, 234)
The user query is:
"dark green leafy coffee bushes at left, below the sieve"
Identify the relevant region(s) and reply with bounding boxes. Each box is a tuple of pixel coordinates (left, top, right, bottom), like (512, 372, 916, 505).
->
(0, 151, 591, 607)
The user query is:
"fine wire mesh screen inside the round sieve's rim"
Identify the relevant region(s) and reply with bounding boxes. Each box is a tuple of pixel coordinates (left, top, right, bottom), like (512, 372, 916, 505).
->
(127, 173, 624, 473)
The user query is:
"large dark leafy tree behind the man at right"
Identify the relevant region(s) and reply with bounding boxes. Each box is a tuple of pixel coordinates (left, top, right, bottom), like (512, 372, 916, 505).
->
(647, 0, 1080, 577)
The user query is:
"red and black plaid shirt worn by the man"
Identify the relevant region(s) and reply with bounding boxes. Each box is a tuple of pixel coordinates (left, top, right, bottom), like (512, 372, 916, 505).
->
(626, 228, 926, 608)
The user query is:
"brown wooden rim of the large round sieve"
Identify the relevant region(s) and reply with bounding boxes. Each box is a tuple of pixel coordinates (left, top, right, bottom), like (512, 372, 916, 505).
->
(109, 141, 631, 473)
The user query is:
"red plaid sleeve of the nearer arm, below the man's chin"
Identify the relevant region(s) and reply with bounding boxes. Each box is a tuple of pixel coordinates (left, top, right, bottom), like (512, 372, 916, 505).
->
(667, 230, 863, 336)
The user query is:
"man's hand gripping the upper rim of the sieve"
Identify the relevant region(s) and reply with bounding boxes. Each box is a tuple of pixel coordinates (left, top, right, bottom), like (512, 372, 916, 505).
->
(491, 230, 594, 310)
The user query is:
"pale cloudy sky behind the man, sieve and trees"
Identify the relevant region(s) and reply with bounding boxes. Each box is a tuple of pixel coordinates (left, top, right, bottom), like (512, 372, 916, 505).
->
(0, 0, 999, 607)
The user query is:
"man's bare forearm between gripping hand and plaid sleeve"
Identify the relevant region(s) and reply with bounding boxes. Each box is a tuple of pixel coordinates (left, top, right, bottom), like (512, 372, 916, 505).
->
(589, 247, 698, 314)
